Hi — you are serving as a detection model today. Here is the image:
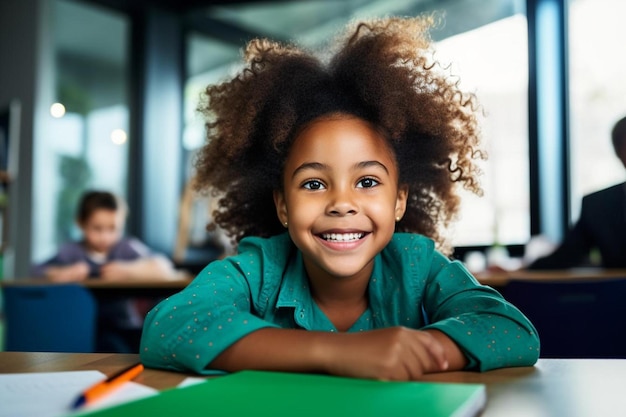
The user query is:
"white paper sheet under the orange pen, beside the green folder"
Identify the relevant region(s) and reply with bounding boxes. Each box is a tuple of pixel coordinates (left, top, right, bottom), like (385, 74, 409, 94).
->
(0, 371, 158, 417)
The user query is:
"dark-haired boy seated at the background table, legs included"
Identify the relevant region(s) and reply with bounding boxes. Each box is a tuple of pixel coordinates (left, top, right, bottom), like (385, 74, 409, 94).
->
(33, 191, 175, 353)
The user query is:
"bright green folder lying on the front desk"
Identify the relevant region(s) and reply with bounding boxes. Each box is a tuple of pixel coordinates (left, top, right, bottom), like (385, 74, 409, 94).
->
(78, 371, 486, 417)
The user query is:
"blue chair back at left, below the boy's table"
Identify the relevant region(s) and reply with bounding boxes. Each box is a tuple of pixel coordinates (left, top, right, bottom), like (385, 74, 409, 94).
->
(3, 284, 97, 352)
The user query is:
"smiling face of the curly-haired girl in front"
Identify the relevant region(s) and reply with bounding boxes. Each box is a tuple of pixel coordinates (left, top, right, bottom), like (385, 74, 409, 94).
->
(274, 116, 407, 279)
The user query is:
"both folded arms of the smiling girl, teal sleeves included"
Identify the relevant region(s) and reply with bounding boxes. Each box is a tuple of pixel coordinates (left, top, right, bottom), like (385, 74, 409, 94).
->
(140, 237, 516, 379)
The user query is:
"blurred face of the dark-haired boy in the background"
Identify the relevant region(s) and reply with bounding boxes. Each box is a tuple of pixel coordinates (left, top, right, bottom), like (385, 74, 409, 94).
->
(79, 209, 124, 254)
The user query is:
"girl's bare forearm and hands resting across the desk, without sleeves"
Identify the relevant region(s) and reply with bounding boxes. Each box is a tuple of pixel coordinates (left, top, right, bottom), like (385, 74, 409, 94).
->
(210, 327, 466, 381)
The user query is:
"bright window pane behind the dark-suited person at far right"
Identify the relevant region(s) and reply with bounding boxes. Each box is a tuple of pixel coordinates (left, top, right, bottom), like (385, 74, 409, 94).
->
(569, 0, 626, 220)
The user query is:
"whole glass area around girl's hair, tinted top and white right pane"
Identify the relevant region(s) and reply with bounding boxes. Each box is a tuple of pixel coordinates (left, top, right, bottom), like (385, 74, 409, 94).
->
(184, 0, 530, 246)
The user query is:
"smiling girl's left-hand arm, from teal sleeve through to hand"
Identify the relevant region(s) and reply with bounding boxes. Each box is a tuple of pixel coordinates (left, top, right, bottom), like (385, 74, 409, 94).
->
(140, 270, 458, 380)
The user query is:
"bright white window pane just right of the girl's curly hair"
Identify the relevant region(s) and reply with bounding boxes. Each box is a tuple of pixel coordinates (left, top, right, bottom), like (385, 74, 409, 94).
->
(437, 13, 530, 246)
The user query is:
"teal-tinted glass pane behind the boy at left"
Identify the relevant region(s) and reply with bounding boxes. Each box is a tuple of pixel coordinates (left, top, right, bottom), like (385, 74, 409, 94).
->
(33, 0, 129, 261)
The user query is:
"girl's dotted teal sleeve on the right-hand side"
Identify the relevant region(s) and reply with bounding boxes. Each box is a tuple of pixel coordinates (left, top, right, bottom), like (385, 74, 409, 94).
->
(423, 253, 539, 371)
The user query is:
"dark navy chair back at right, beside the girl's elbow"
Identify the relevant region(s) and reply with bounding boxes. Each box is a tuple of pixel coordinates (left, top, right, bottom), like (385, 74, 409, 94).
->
(502, 278, 626, 358)
